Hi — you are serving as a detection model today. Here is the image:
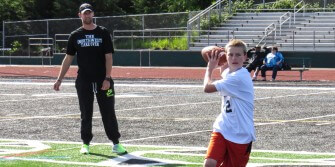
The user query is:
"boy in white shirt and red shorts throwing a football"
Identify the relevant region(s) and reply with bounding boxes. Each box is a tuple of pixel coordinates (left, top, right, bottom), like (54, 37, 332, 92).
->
(203, 39, 256, 167)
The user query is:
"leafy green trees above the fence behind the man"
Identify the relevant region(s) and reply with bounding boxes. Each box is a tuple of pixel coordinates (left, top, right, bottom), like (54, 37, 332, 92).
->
(0, 0, 215, 22)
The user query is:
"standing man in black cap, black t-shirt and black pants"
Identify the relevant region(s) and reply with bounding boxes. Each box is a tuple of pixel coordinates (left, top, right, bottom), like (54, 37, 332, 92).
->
(54, 3, 126, 154)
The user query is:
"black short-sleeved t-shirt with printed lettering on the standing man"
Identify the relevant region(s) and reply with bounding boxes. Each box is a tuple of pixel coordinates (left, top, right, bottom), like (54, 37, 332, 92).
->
(66, 26, 114, 81)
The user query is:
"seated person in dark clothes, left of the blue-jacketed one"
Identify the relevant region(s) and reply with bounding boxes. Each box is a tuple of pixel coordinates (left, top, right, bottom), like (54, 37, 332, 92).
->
(246, 45, 270, 81)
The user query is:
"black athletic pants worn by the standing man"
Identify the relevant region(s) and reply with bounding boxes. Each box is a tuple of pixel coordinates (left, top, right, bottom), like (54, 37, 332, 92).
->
(76, 77, 121, 144)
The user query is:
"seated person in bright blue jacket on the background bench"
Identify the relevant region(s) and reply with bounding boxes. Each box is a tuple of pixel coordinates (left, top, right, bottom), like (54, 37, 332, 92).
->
(261, 46, 284, 81)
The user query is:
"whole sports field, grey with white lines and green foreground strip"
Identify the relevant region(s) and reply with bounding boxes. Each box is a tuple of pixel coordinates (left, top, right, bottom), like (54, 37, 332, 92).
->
(0, 78, 335, 167)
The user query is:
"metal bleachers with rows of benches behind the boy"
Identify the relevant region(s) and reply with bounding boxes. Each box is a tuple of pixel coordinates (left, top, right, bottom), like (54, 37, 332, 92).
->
(189, 1, 335, 51)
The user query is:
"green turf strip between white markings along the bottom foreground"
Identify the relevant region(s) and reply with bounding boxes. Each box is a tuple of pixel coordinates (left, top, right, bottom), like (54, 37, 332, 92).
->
(0, 141, 335, 167)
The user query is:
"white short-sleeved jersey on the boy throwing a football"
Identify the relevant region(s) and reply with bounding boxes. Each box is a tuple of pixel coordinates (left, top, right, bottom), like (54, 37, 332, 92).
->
(213, 68, 256, 144)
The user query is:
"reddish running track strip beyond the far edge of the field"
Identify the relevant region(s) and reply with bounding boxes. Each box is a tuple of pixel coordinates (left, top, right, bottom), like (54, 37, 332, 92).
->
(0, 65, 335, 81)
